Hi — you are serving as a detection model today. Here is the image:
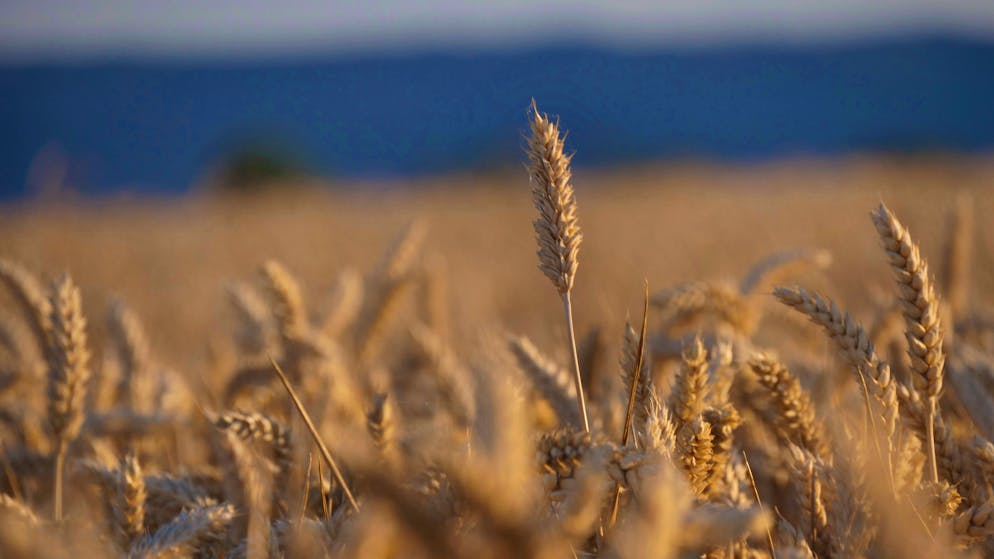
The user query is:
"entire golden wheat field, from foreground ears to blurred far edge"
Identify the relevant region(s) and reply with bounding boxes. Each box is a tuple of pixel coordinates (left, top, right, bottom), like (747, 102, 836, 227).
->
(0, 110, 994, 559)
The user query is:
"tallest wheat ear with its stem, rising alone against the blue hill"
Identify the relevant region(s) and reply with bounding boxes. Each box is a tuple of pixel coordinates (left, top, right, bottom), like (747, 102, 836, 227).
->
(528, 101, 590, 431)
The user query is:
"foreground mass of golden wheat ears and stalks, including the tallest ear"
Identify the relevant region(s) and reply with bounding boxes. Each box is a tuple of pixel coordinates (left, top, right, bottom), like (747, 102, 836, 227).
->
(0, 106, 994, 559)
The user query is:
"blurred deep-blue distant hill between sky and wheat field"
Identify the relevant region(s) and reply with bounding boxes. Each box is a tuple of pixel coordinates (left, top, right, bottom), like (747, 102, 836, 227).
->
(0, 37, 994, 199)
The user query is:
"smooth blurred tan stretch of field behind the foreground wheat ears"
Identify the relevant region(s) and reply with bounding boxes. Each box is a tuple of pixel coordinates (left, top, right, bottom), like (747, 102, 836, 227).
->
(0, 158, 994, 366)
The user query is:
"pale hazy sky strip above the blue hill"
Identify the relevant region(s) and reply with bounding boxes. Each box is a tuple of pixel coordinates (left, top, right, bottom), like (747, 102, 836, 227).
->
(0, 0, 994, 60)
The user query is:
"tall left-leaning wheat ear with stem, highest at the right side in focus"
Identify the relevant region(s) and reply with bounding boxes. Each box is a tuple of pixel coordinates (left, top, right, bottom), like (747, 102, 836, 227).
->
(871, 204, 946, 483)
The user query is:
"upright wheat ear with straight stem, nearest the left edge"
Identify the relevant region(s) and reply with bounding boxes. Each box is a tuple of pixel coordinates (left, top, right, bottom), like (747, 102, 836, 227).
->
(48, 274, 90, 522)
